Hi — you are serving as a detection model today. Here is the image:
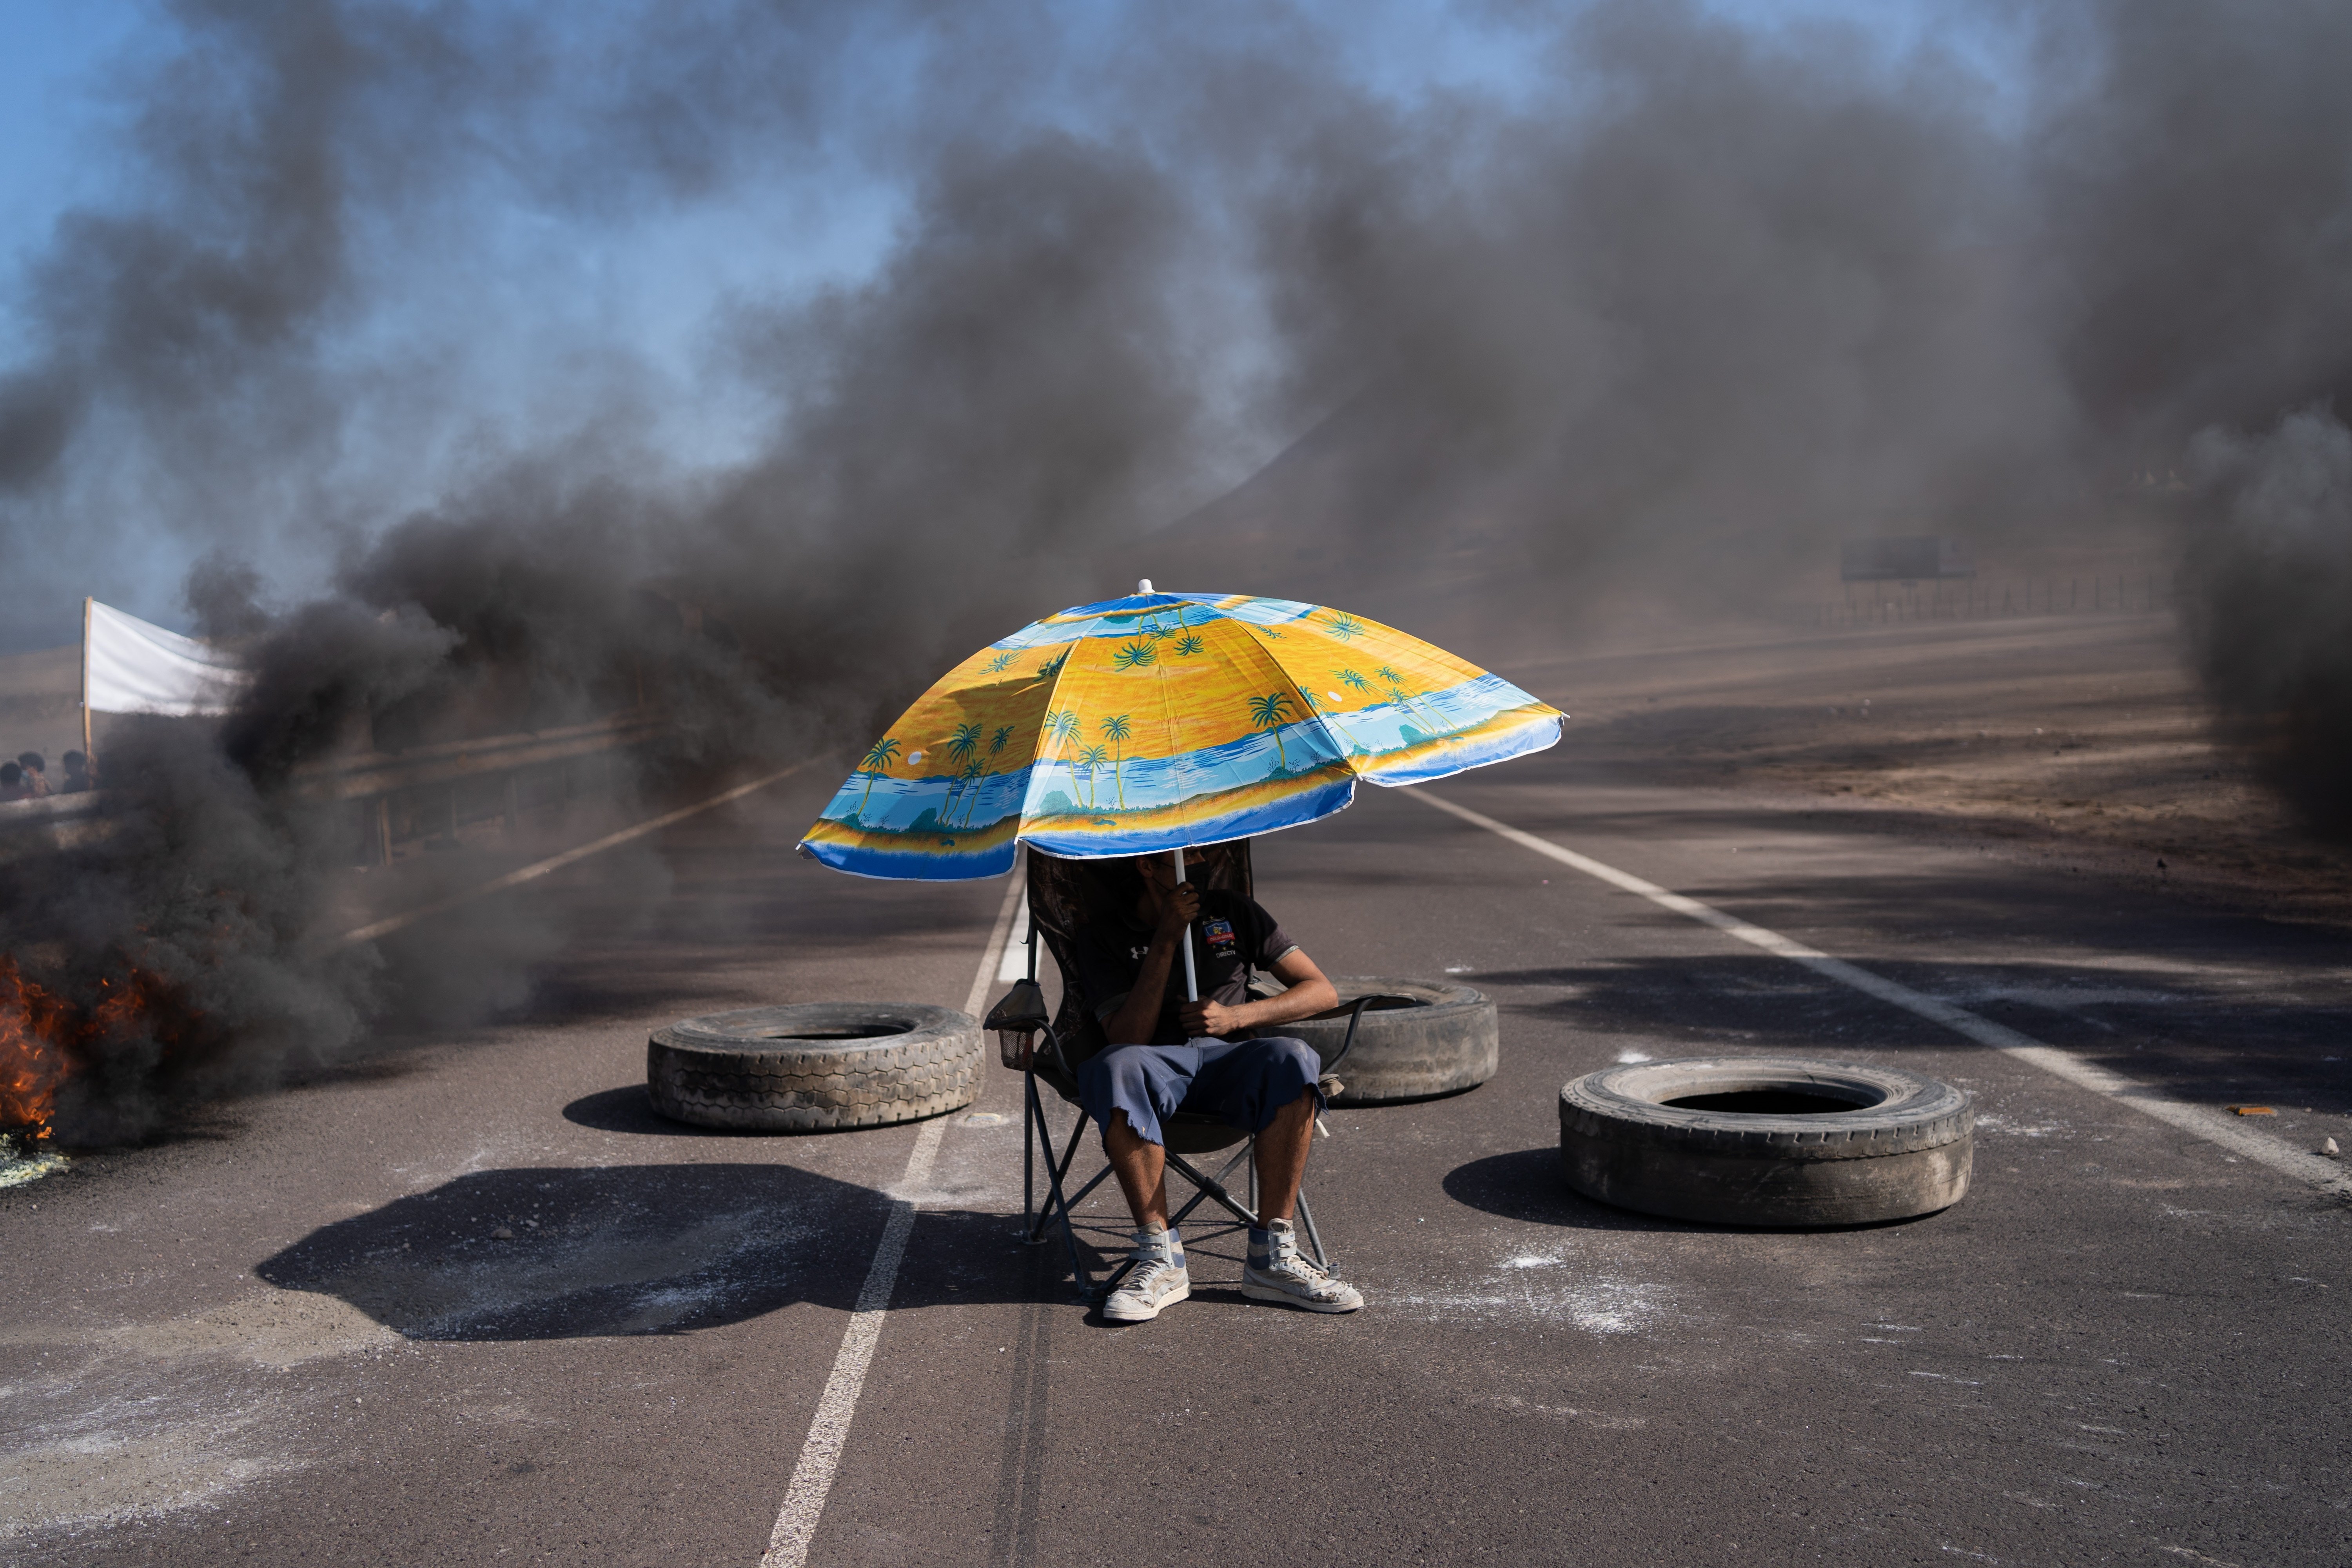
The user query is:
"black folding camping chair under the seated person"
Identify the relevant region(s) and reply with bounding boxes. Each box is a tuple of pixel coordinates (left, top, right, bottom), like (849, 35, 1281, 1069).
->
(983, 839, 1371, 1300)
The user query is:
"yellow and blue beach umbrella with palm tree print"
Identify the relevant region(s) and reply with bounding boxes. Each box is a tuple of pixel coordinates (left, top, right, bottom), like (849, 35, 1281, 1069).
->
(800, 583, 1566, 882)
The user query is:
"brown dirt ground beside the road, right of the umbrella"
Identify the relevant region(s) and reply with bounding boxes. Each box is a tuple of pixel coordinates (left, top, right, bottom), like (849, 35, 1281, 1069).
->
(1505, 611, 2352, 926)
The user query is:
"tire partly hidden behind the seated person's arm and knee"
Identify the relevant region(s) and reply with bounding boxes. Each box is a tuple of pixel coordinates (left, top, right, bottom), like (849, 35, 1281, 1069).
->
(1268, 976, 1501, 1105)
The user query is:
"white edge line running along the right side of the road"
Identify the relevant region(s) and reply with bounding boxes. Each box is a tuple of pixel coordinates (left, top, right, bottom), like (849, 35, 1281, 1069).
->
(1399, 790, 2352, 1196)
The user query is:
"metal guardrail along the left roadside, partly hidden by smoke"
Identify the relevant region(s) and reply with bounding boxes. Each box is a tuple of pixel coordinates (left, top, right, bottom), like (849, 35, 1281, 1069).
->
(0, 710, 668, 865)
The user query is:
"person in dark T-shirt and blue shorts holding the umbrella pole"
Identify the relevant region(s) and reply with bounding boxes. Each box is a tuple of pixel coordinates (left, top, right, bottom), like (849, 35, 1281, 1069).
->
(1075, 856, 1364, 1323)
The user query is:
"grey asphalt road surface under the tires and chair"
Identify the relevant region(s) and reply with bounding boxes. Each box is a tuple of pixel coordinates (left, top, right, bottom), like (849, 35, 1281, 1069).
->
(0, 748, 2352, 1568)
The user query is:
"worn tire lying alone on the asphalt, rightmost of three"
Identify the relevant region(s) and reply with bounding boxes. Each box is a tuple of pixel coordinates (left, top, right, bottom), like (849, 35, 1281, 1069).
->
(1559, 1058, 1976, 1229)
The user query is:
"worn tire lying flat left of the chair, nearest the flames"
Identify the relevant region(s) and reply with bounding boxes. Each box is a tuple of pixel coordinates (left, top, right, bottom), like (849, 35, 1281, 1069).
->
(644, 1002, 981, 1133)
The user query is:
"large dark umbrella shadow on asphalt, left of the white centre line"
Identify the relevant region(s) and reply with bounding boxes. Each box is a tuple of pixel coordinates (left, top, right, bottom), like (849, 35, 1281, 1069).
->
(254, 1161, 887, 1340)
